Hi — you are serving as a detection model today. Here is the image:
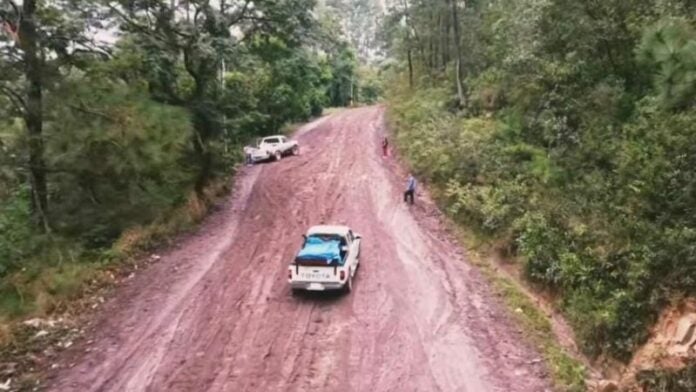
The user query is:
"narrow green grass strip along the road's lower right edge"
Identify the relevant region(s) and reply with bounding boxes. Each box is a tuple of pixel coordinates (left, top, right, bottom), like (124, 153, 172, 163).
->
(458, 226, 587, 392)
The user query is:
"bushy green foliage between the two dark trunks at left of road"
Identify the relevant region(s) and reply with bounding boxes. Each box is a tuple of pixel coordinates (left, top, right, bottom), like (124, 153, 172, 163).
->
(46, 79, 193, 246)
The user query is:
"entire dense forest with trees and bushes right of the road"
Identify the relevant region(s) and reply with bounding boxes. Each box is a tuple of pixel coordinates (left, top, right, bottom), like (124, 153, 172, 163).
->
(382, 0, 696, 372)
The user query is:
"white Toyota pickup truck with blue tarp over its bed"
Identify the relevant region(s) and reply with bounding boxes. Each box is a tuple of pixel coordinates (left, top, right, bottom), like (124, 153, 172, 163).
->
(288, 226, 361, 293)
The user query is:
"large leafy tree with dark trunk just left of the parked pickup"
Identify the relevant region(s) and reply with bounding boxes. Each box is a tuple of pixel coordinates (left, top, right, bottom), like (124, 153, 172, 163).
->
(107, 0, 314, 193)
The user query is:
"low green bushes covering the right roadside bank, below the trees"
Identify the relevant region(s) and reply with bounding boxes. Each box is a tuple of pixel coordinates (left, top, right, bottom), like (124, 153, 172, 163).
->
(391, 82, 696, 359)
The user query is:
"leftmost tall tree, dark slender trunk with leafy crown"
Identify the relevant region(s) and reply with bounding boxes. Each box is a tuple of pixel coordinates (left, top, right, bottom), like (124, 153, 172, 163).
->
(0, 0, 105, 231)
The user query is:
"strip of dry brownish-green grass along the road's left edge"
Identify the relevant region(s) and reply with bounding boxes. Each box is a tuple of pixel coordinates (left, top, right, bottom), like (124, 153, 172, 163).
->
(0, 183, 221, 326)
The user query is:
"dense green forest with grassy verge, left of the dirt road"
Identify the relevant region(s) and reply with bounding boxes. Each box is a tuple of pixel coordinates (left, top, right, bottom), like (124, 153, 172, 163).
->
(0, 0, 378, 320)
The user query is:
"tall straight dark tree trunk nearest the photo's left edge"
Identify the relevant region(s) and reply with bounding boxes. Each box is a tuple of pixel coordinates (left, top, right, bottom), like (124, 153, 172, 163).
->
(19, 0, 49, 232)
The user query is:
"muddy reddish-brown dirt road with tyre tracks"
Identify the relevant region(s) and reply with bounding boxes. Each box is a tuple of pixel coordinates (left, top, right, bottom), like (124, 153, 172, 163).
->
(49, 107, 549, 392)
